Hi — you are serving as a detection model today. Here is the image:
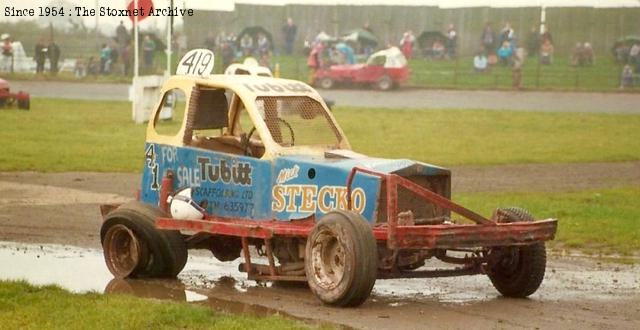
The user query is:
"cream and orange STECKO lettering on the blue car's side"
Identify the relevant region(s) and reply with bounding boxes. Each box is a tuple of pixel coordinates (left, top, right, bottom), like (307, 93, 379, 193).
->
(271, 184, 367, 214)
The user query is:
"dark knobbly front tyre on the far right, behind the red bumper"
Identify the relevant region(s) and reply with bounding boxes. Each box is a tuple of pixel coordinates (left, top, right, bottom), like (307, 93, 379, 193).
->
(489, 207, 547, 298)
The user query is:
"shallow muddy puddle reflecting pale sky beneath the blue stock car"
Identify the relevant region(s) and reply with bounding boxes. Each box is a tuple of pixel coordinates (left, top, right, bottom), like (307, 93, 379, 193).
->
(0, 242, 640, 310)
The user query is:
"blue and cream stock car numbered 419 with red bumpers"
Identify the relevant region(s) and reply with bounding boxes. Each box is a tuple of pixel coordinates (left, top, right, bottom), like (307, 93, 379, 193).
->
(100, 50, 557, 306)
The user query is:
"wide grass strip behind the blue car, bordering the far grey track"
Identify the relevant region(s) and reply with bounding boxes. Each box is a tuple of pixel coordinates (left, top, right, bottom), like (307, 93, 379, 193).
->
(0, 99, 640, 172)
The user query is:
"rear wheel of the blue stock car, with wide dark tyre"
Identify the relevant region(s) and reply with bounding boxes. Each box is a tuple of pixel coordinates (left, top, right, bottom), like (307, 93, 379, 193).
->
(100, 202, 187, 278)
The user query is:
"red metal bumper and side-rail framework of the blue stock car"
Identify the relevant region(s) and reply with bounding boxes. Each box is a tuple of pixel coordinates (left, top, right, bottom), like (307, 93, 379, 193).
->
(136, 167, 557, 281)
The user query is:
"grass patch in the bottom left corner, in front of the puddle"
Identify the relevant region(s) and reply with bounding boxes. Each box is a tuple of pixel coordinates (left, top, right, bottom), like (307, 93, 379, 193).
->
(0, 281, 307, 329)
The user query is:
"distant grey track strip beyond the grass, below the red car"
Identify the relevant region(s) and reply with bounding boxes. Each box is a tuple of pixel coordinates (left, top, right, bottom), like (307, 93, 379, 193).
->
(11, 81, 640, 114)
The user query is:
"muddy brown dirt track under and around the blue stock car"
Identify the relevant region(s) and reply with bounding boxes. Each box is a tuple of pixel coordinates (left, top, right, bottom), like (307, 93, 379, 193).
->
(0, 162, 640, 329)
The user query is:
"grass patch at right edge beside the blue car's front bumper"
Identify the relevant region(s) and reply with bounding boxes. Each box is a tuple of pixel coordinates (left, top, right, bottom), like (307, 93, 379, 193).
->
(454, 187, 640, 255)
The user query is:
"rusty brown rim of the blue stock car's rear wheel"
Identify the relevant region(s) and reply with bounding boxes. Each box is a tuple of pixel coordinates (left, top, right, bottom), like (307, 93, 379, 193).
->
(103, 224, 141, 278)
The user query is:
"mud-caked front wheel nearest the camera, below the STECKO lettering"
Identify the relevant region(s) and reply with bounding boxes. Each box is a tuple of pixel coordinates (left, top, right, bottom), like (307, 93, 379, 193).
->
(305, 211, 378, 307)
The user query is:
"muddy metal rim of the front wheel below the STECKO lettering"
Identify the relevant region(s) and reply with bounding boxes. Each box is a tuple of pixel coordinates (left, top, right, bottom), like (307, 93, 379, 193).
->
(311, 227, 346, 290)
